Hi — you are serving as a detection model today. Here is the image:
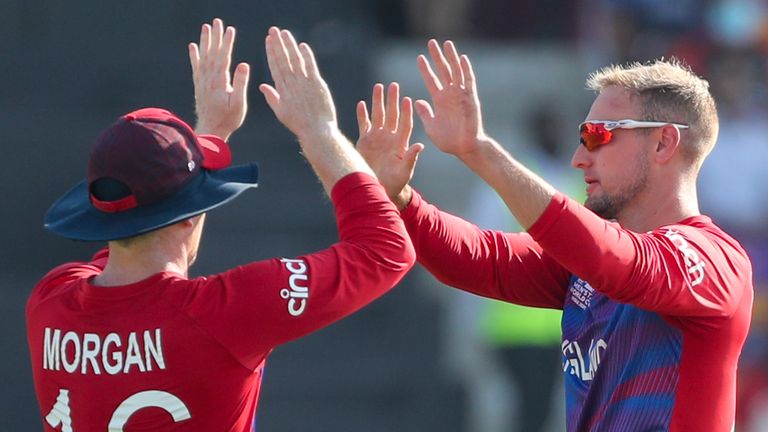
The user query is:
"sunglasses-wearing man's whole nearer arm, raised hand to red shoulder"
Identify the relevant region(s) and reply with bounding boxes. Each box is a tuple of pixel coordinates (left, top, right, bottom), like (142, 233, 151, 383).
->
(416, 40, 748, 317)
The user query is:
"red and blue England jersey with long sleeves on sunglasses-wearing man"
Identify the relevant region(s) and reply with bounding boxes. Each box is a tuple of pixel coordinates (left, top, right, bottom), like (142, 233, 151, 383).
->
(402, 193, 753, 432)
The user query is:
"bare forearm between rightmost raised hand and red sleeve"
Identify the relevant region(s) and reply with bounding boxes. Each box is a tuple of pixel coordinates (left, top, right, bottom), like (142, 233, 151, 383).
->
(459, 138, 557, 229)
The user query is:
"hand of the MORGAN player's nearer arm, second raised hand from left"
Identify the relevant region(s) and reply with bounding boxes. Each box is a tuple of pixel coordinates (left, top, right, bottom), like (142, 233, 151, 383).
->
(259, 27, 338, 141)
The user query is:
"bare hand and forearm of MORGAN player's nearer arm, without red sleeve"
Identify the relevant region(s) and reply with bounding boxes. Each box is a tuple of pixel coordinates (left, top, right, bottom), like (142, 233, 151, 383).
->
(259, 27, 373, 194)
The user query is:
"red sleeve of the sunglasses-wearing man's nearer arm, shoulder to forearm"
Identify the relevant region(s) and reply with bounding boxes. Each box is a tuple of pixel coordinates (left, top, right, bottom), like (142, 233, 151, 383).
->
(529, 194, 751, 317)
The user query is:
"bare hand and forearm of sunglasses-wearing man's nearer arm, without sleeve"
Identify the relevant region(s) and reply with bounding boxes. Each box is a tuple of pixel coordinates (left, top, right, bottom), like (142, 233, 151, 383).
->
(416, 39, 556, 229)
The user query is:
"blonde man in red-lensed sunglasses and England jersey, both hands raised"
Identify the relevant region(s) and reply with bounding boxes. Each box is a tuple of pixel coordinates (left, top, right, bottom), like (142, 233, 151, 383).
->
(358, 40, 753, 432)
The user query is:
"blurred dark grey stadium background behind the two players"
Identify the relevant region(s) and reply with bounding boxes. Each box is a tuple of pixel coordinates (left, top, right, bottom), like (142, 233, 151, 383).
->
(0, 0, 768, 432)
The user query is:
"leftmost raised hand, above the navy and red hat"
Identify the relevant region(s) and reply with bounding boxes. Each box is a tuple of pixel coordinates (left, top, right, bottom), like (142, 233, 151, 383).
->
(188, 18, 250, 140)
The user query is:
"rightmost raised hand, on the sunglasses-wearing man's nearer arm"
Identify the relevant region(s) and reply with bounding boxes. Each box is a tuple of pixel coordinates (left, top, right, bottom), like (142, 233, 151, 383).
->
(415, 39, 485, 157)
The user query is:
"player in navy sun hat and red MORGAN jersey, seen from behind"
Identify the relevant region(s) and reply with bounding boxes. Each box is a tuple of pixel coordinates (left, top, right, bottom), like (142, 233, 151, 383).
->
(27, 19, 415, 432)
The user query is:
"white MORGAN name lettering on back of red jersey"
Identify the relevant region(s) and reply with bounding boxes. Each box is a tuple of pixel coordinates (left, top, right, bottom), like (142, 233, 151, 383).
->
(43, 327, 165, 375)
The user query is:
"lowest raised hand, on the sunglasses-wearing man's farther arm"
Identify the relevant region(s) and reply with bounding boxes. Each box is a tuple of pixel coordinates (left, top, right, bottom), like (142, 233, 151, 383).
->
(357, 83, 424, 207)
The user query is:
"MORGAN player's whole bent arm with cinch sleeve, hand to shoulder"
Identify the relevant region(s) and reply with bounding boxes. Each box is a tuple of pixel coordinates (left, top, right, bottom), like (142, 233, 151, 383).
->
(182, 27, 416, 369)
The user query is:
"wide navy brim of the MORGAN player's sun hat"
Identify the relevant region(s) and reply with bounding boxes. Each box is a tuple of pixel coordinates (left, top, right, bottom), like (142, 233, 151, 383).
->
(44, 164, 259, 241)
